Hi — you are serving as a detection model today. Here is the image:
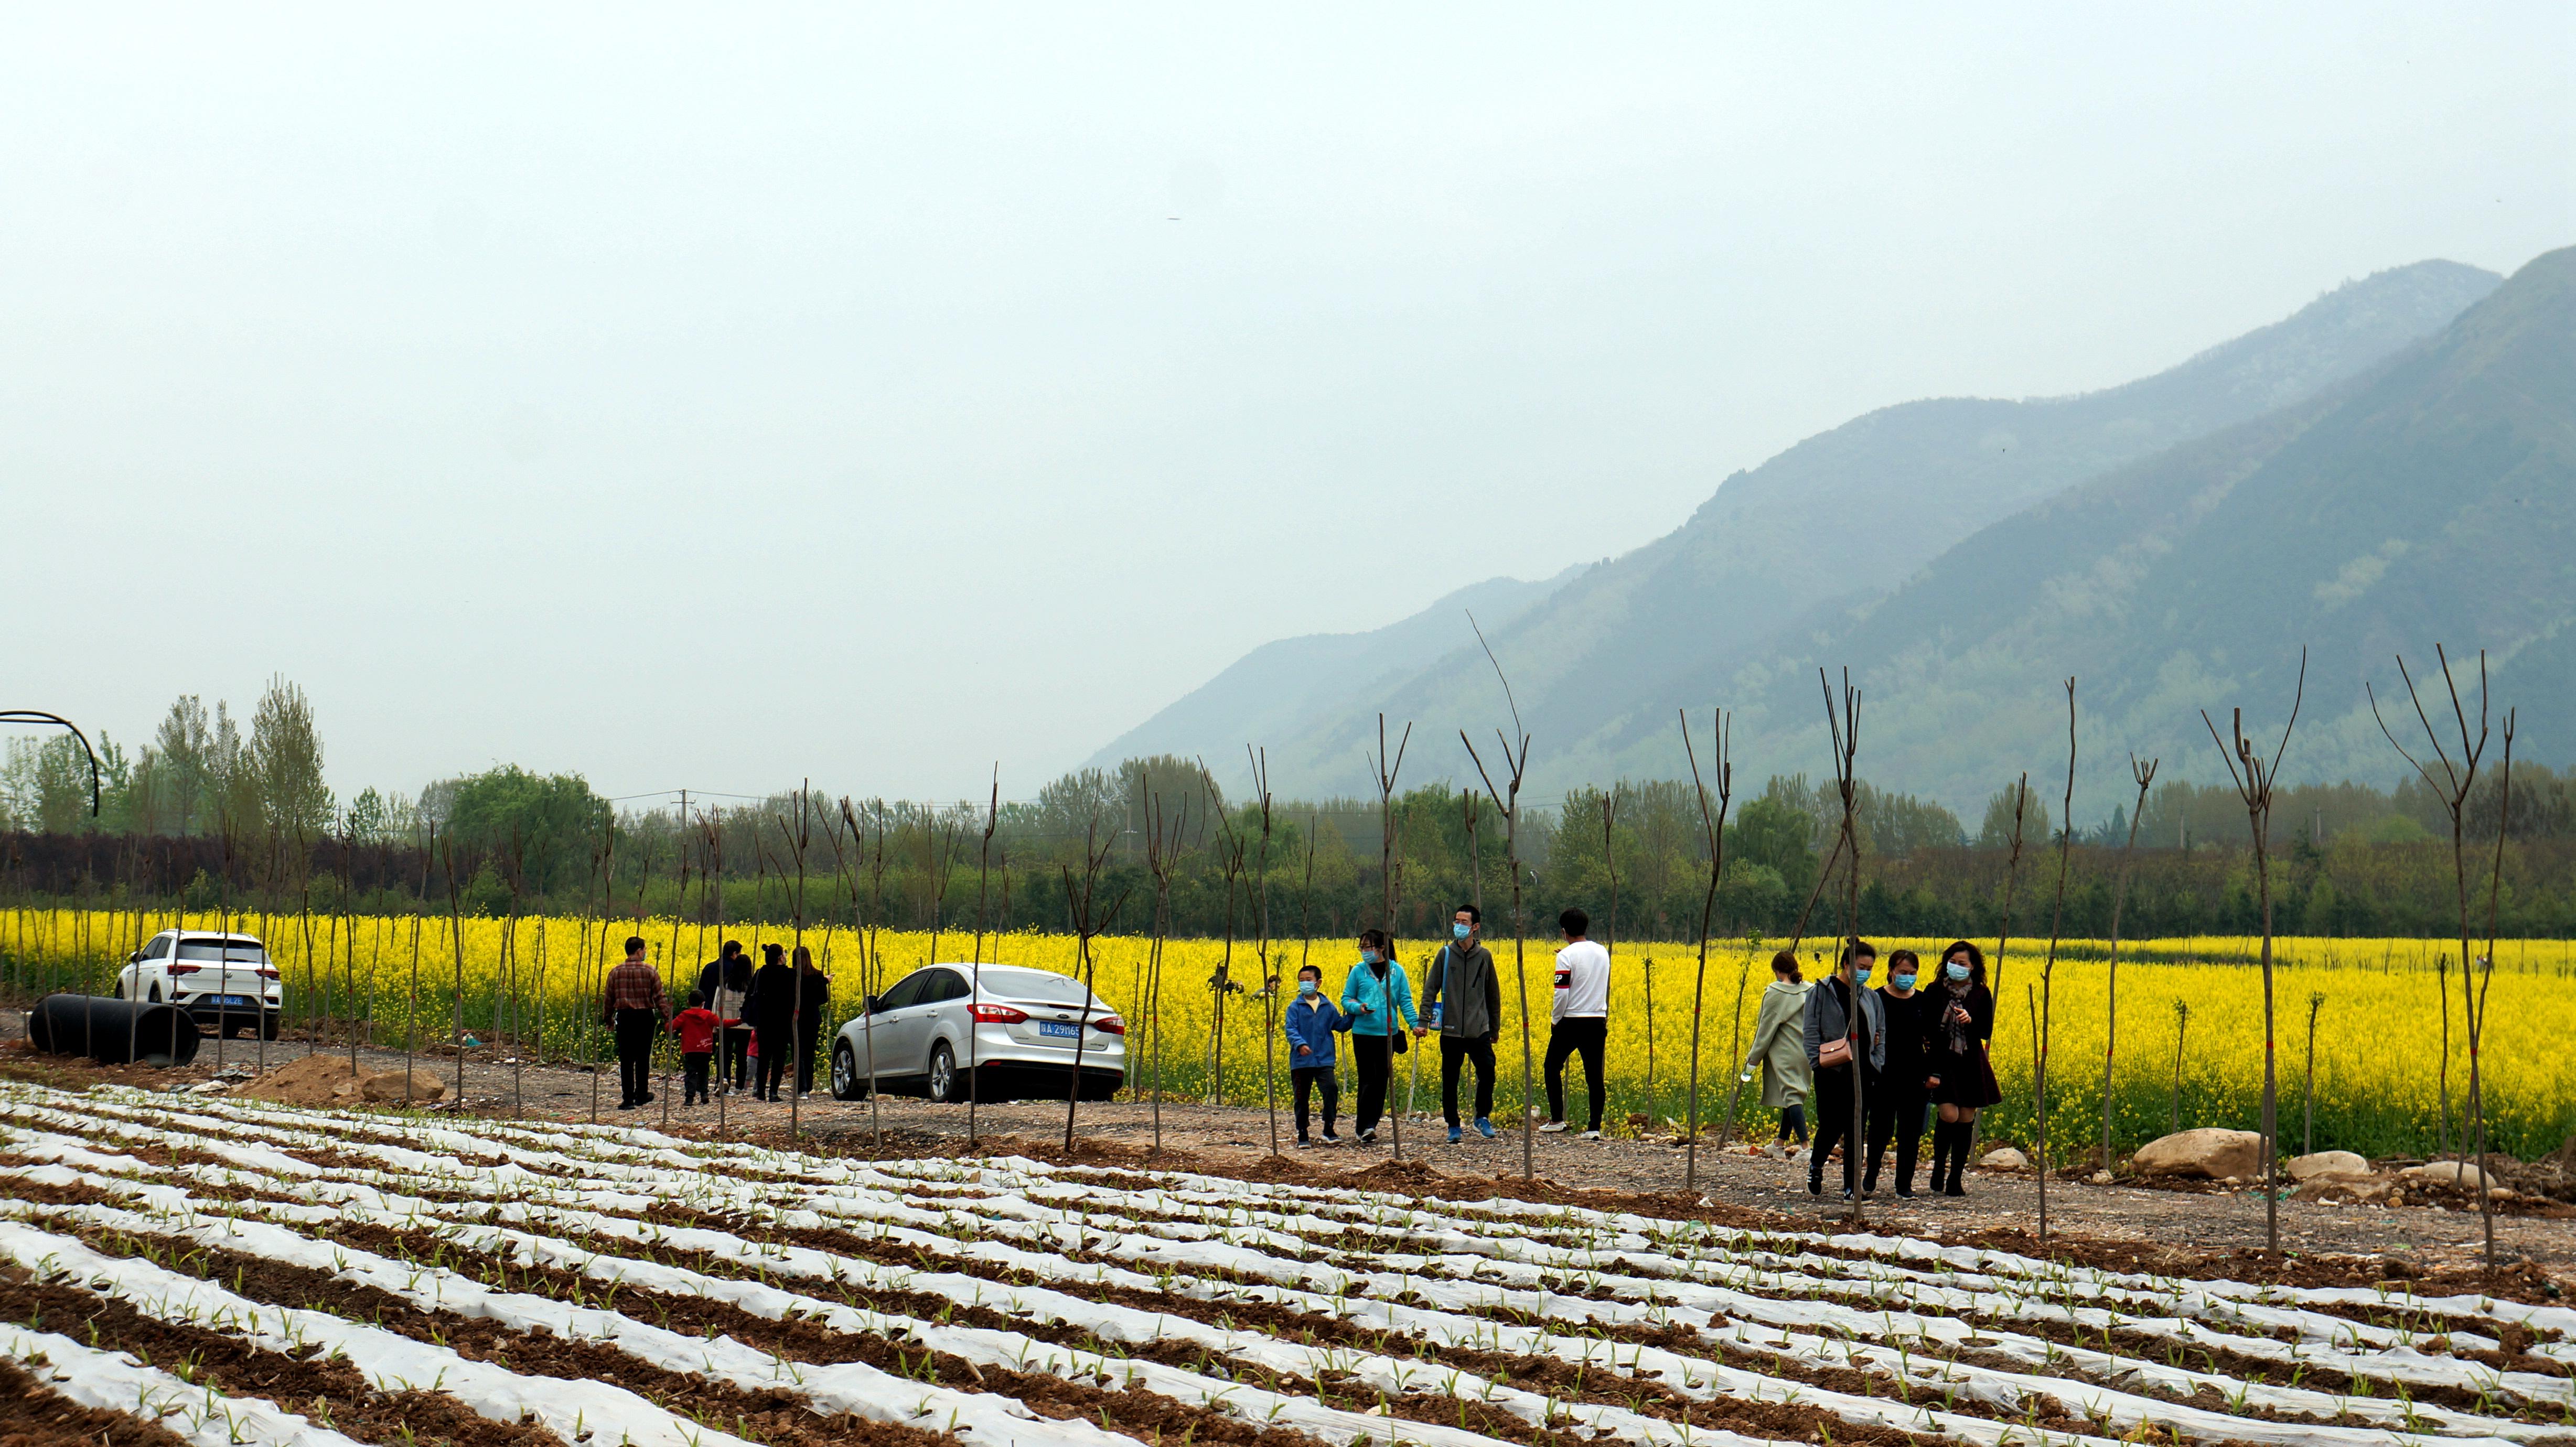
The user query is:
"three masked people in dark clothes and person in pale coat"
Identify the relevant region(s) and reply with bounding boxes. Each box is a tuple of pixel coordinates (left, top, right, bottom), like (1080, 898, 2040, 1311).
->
(1742, 940, 2004, 1197)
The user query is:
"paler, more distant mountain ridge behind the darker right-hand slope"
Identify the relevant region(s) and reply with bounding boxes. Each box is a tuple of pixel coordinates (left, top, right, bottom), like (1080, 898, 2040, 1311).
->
(1095, 260, 2504, 806)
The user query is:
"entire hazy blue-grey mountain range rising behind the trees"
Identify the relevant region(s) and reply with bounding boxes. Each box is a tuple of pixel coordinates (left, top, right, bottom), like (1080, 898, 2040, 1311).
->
(1100, 252, 2576, 816)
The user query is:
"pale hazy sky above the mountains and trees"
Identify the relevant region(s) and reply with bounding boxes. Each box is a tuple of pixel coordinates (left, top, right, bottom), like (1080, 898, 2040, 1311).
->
(0, 0, 2576, 798)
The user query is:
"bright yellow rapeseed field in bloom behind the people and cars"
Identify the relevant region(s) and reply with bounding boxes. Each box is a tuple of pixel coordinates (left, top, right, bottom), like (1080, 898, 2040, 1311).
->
(0, 909, 2576, 1159)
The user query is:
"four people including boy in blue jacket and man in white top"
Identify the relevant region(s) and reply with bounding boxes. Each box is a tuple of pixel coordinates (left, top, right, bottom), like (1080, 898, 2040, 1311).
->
(1280, 904, 1610, 1146)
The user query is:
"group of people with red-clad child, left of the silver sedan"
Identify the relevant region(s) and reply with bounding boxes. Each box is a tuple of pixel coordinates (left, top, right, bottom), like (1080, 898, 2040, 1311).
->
(600, 935, 832, 1110)
